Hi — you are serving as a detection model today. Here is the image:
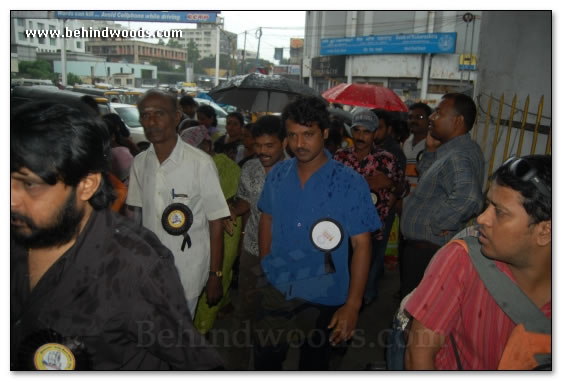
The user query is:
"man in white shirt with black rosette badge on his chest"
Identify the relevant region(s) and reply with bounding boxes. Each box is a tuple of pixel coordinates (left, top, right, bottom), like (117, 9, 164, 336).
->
(127, 89, 230, 318)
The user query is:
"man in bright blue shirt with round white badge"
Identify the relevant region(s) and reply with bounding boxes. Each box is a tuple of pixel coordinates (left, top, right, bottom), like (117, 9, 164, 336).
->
(254, 97, 381, 370)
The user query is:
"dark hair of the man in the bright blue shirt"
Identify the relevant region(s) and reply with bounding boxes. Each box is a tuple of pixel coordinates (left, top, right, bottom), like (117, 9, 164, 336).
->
(281, 96, 330, 131)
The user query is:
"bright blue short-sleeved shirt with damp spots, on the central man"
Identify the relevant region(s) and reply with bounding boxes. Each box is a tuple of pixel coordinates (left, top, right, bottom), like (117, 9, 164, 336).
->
(258, 153, 381, 306)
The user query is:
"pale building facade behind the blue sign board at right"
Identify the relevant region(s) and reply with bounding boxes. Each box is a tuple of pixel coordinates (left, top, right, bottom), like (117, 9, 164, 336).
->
(302, 11, 482, 104)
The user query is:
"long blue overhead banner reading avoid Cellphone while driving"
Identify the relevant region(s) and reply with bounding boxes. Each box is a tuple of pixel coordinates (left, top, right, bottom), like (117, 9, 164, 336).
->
(55, 11, 220, 23)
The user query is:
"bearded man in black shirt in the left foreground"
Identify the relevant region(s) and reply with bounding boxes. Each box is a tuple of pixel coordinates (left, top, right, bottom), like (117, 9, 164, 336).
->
(10, 101, 222, 370)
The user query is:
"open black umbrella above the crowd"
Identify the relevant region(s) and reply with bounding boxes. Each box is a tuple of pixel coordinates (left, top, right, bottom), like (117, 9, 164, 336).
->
(209, 73, 321, 112)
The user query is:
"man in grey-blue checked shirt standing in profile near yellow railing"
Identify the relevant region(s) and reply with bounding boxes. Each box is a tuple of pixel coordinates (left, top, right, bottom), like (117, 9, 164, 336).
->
(401, 93, 485, 296)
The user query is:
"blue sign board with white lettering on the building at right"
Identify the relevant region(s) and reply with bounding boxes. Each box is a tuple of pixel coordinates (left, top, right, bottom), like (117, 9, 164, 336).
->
(321, 32, 457, 56)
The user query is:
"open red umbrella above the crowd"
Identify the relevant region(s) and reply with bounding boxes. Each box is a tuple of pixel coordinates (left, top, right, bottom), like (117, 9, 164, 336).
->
(323, 84, 408, 112)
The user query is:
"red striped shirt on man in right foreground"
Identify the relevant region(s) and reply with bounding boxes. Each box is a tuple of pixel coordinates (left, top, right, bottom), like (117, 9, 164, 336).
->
(405, 243, 551, 370)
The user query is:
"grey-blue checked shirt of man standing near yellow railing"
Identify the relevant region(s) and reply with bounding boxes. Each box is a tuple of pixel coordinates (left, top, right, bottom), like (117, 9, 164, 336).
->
(401, 134, 485, 245)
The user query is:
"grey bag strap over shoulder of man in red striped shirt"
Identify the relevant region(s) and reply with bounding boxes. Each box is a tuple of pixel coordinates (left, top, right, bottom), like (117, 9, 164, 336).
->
(463, 236, 551, 334)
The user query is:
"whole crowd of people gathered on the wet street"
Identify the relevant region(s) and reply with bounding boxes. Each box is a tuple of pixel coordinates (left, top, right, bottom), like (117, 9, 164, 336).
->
(10, 89, 551, 370)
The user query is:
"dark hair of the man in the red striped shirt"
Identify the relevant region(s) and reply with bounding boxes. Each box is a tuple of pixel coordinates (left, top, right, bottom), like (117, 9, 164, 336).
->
(491, 155, 551, 223)
